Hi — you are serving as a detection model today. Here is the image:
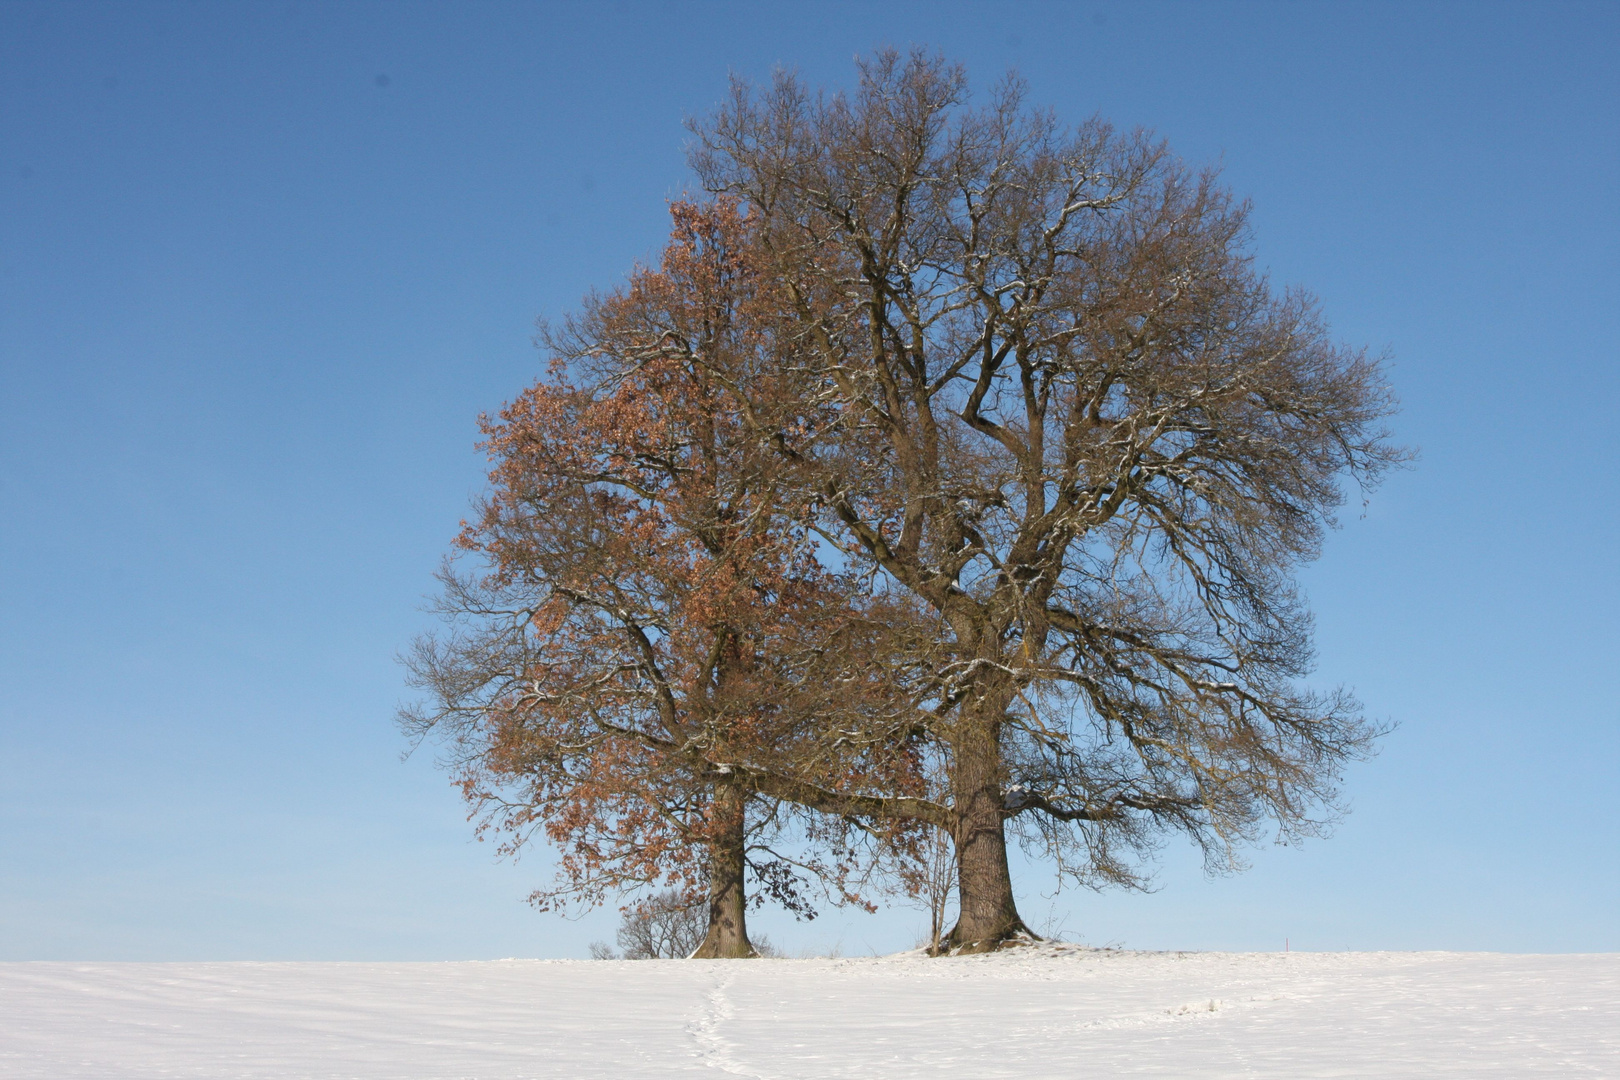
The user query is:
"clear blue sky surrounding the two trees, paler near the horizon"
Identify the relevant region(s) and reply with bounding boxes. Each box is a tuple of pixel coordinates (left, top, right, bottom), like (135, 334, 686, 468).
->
(0, 2, 1620, 960)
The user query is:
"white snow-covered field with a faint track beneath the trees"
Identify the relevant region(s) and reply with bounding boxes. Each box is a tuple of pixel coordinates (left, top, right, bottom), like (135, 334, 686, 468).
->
(0, 946, 1620, 1080)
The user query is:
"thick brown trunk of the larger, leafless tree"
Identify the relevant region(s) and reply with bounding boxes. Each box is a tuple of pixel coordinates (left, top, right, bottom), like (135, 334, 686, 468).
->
(941, 695, 1034, 952)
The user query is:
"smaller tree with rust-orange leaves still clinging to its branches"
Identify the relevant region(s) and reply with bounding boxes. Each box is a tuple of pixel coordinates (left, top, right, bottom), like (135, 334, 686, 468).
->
(402, 202, 923, 955)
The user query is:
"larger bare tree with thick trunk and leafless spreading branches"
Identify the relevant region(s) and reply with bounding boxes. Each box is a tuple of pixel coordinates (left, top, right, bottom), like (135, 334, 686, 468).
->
(693, 52, 1401, 949)
